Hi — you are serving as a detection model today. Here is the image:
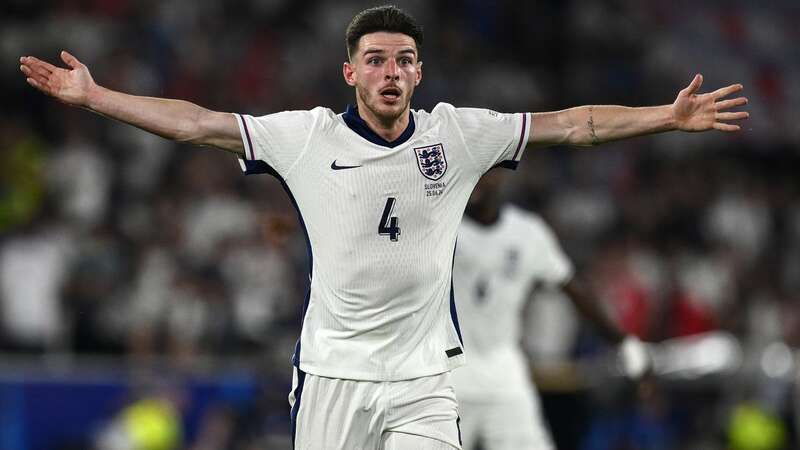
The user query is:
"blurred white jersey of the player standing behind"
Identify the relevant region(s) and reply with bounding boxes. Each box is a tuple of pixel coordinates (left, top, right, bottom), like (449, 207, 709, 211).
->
(453, 205, 573, 399)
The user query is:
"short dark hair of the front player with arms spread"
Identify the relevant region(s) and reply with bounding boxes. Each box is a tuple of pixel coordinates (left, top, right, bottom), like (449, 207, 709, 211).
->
(345, 5, 423, 57)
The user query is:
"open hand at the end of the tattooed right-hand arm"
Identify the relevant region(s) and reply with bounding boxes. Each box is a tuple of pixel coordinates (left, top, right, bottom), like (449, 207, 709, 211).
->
(672, 74, 750, 131)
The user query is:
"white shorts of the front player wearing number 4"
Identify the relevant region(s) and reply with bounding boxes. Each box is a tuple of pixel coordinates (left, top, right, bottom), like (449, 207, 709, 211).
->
(289, 368, 461, 450)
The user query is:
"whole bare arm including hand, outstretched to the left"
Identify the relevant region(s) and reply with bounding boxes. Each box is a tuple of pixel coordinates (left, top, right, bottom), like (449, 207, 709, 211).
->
(20, 51, 244, 155)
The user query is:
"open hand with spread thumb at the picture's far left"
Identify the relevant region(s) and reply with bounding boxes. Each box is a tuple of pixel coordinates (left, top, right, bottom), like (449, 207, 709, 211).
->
(19, 51, 96, 106)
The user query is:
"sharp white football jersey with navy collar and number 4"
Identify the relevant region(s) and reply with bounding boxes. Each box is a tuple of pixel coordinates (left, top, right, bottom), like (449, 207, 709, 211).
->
(236, 103, 531, 381)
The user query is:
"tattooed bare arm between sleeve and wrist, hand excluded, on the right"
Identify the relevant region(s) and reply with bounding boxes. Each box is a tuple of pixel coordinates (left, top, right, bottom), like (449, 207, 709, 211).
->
(531, 105, 675, 146)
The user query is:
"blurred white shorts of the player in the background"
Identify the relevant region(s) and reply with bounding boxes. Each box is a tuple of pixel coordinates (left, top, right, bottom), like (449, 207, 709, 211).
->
(459, 393, 555, 450)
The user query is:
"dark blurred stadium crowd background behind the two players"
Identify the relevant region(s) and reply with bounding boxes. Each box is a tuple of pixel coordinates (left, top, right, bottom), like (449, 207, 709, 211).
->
(0, 0, 800, 450)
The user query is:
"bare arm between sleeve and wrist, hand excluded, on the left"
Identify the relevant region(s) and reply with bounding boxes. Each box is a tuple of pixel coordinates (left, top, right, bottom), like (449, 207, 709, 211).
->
(85, 85, 240, 152)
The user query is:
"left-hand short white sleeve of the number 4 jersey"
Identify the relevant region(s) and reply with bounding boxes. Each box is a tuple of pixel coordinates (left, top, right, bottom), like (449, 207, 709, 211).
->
(234, 110, 315, 178)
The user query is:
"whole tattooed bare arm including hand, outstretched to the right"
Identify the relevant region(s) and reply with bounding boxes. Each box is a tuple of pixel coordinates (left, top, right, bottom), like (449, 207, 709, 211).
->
(528, 74, 749, 147)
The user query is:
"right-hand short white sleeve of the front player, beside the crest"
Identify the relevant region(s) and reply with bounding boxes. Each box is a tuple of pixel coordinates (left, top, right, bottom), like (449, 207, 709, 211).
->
(455, 108, 531, 172)
